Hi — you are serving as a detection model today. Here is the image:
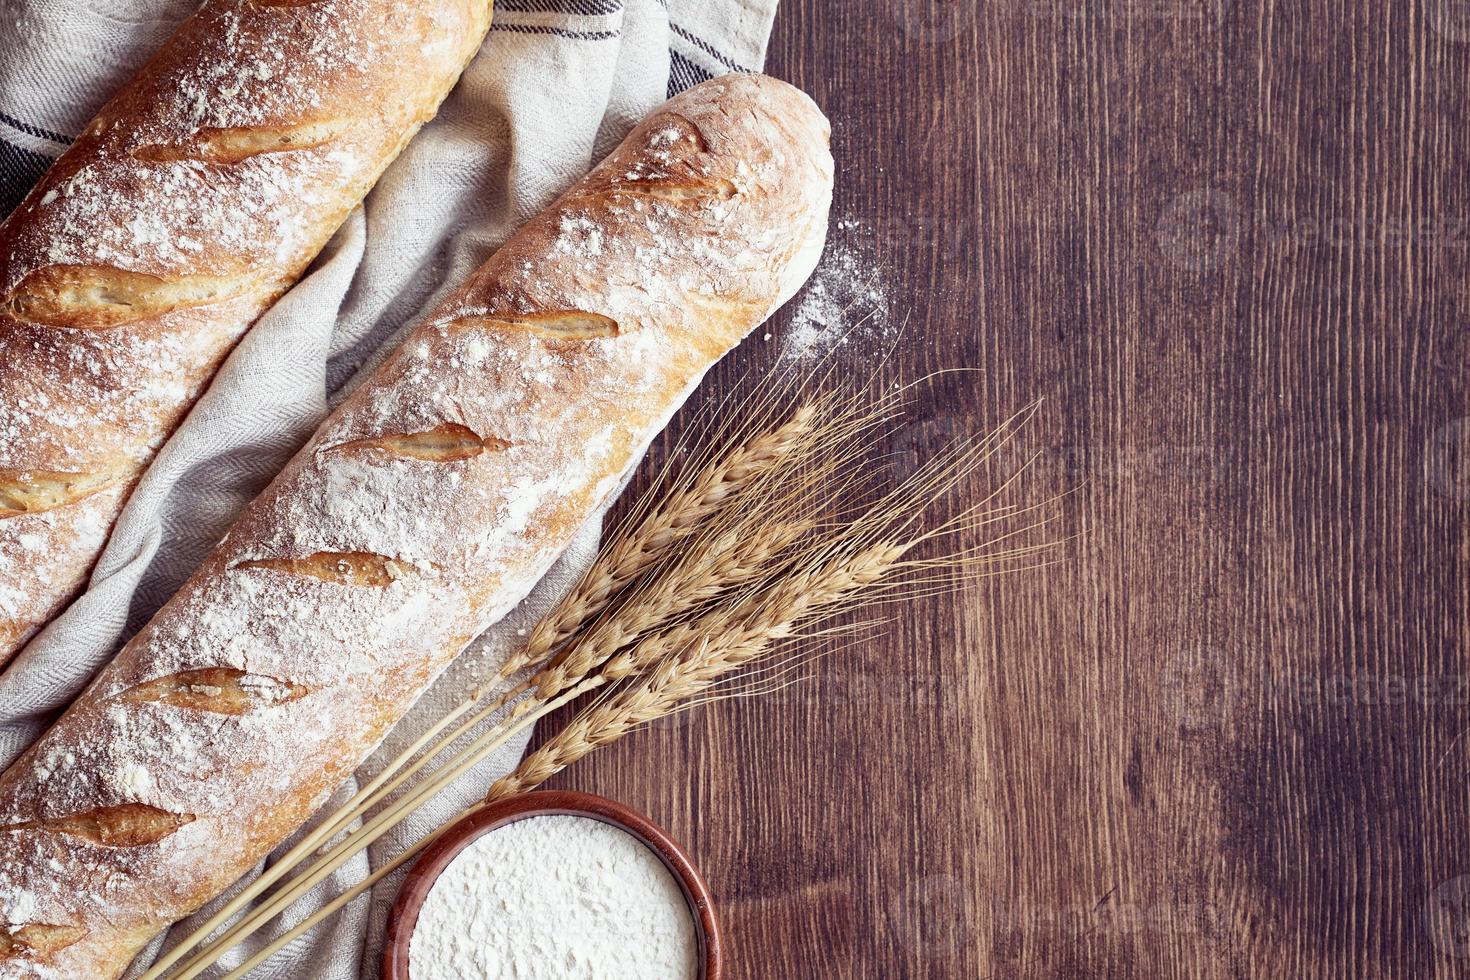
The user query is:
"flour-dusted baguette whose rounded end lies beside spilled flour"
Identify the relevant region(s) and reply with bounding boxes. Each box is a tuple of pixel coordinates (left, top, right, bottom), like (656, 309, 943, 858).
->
(0, 75, 832, 979)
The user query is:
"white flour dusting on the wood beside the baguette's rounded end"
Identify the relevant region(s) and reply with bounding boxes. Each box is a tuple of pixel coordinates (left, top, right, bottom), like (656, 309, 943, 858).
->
(781, 217, 898, 363)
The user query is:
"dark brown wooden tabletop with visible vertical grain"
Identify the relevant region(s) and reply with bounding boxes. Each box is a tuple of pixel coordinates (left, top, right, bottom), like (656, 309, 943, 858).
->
(538, 0, 1470, 980)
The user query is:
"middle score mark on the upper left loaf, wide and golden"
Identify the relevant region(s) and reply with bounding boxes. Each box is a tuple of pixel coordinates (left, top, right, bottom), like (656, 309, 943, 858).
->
(0, 264, 254, 331)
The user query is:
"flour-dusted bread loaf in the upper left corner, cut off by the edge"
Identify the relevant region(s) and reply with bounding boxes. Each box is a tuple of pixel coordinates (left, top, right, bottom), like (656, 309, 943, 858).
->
(0, 0, 491, 667)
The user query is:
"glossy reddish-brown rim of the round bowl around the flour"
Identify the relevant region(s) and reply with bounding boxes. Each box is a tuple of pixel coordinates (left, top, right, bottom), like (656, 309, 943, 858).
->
(382, 790, 722, 980)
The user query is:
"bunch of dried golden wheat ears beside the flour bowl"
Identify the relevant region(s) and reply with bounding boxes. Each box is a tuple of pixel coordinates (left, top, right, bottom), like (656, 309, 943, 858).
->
(163, 384, 1058, 980)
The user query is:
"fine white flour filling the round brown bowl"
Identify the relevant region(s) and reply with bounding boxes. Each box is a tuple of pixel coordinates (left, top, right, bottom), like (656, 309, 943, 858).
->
(409, 815, 698, 980)
